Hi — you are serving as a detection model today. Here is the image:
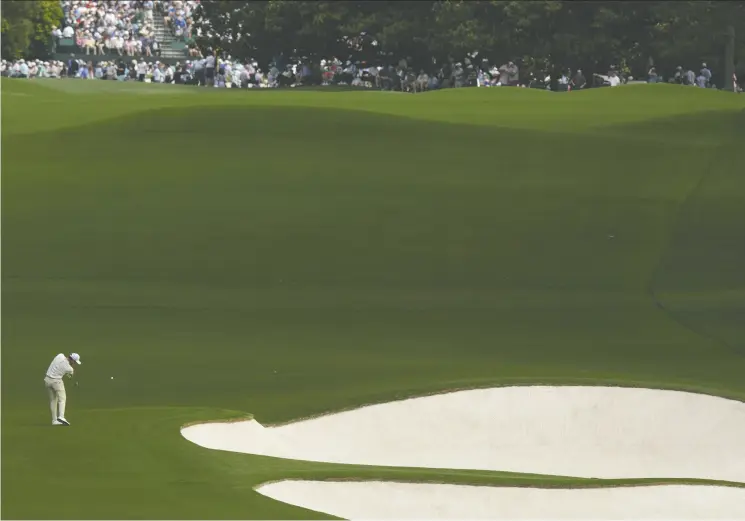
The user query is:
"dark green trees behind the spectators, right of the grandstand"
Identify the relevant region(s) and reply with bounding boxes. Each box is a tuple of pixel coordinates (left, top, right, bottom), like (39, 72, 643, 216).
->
(195, 0, 745, 85)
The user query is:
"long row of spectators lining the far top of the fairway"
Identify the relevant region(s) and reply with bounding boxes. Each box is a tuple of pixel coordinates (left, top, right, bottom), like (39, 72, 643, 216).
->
(2, 52, 742, 93)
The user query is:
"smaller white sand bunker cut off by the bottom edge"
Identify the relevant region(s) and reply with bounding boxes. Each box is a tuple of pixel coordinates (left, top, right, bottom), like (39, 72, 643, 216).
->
(258, 481, 745, 520)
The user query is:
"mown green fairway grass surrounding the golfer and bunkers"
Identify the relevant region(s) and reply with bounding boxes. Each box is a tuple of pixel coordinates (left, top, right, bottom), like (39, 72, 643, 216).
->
(2, 80, 745, 519)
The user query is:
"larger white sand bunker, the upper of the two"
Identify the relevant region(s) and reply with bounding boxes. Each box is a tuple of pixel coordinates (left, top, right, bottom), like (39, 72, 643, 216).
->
(182, 386, 745, 480)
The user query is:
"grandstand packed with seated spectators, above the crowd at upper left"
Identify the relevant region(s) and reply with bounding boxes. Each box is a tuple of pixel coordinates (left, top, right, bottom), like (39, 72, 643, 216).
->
(52, 0, 199, 63)
